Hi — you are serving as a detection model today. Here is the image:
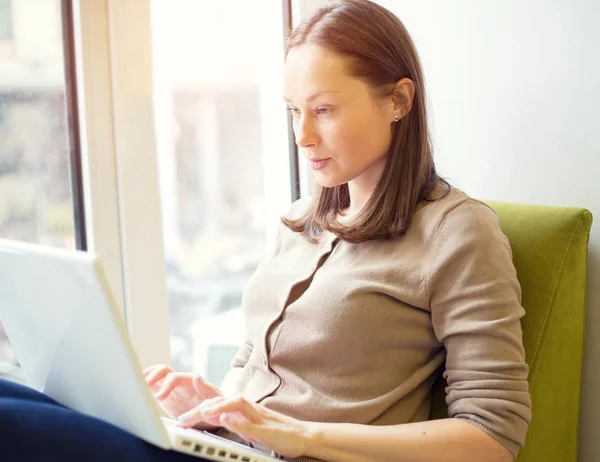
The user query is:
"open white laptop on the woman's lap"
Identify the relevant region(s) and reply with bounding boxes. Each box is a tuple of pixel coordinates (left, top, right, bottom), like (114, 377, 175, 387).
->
(0, 239, 280, 462)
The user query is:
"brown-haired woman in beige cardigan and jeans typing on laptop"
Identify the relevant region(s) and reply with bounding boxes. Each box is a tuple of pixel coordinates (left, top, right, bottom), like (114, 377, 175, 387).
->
(0, 0, 531, 462)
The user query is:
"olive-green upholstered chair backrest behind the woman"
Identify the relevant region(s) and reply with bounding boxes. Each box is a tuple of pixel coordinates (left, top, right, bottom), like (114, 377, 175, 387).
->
(431, 201, 592, 462)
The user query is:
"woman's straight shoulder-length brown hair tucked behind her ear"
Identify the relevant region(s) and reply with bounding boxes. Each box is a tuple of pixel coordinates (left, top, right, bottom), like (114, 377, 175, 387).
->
(281, 0, 450, 242)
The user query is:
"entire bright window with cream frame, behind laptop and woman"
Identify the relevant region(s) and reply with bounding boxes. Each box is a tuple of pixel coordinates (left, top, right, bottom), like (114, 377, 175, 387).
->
(0, 0, 298, 382)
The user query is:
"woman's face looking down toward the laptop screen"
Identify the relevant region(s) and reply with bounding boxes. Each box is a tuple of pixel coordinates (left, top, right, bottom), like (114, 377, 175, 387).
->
(284, 45, 402, 187)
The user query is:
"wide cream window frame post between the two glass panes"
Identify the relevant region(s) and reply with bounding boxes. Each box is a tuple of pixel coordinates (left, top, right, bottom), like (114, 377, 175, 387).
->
(74, 0, 171, 367)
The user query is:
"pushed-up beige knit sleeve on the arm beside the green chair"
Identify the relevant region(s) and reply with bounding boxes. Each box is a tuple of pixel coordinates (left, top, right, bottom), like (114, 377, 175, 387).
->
(426, 199, 531, 456)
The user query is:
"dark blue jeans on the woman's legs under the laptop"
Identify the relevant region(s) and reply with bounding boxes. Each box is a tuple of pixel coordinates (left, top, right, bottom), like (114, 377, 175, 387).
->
(0, 379, 206, 462)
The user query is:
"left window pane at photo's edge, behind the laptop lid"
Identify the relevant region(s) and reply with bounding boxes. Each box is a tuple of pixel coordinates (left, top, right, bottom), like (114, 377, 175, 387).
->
(0, 0, 76, 380)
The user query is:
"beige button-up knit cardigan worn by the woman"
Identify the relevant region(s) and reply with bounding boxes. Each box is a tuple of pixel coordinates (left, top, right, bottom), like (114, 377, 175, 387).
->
(220, 188, 531, 461)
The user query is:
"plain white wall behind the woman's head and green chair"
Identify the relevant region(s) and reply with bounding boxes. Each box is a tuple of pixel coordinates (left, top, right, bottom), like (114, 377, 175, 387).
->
(378, 0, 600, 462)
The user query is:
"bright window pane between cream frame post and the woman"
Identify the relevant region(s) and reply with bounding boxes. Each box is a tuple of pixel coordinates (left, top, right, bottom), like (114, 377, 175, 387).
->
(151, 0, 291, 384)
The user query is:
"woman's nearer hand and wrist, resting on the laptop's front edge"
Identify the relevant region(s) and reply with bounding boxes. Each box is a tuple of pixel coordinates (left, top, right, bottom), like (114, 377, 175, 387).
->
(179, 397, 311, 457)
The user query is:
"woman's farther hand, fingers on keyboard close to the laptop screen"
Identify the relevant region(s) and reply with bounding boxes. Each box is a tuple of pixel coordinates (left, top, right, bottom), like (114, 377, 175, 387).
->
(143, 365, 224, 430)
